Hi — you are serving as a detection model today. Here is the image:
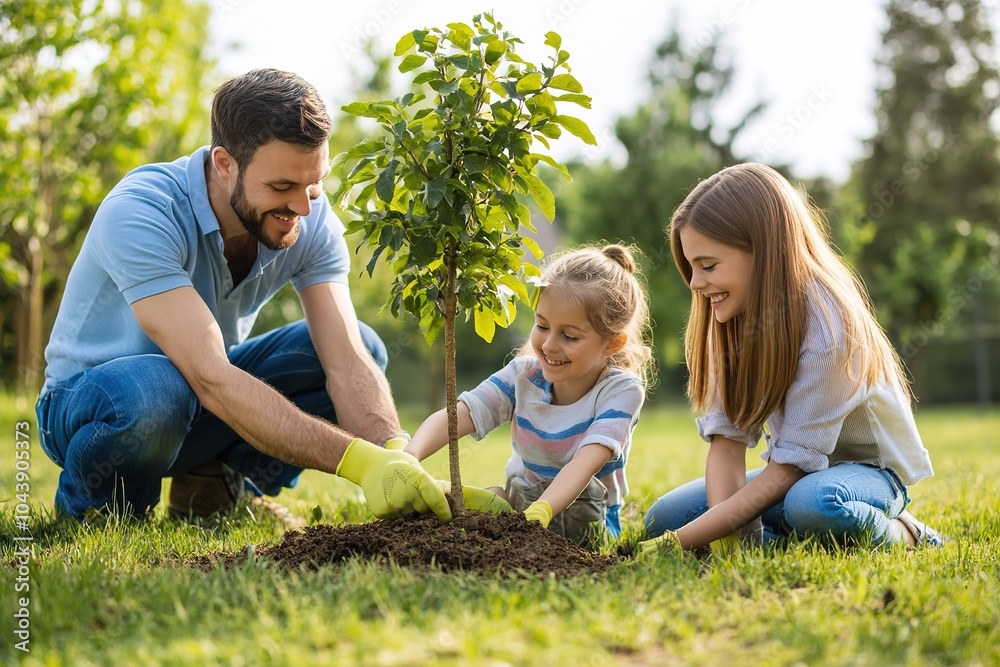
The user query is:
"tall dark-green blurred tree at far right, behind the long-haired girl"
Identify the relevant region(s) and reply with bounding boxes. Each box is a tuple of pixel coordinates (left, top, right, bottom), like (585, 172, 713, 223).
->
(840, 0, 1000, 397)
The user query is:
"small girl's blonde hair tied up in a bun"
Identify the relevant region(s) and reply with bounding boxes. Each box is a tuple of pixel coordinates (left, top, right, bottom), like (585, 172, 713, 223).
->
(521, 244, 655, 387)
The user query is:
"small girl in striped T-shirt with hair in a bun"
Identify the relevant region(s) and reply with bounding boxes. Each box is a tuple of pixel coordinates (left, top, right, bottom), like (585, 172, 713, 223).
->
(406, 245, 652, 541)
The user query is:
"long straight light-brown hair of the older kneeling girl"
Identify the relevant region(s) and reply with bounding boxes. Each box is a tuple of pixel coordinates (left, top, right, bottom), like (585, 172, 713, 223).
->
(668, 163, 910, 430)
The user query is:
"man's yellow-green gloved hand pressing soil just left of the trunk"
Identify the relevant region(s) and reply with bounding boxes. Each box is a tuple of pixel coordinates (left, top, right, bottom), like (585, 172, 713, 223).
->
(337, 438, 451, 521)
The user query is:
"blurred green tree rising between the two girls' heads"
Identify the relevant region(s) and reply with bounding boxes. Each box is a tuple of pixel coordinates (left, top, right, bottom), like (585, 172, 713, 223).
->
(557, 30, 764, 394)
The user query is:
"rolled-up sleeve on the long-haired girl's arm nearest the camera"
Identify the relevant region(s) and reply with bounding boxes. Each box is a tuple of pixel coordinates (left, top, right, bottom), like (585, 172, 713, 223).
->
(768, 347, 865, 473)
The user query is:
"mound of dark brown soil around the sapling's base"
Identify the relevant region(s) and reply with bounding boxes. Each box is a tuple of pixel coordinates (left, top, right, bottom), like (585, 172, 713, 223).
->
(187, 512, 621, 578)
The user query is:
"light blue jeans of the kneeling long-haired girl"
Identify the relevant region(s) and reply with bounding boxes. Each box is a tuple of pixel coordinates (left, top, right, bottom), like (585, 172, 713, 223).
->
(646, 463, 910, 545)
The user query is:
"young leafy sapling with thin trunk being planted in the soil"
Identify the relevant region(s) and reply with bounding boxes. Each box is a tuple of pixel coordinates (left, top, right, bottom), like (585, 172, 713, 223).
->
(335, 14, 595, 514)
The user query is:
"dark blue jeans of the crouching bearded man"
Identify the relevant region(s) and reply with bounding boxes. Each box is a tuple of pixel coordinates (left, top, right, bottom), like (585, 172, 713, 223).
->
(35, 320, 388, 519)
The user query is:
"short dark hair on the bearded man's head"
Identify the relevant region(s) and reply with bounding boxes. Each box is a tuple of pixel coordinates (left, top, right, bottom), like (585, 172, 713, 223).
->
(212, 69, 333, 169)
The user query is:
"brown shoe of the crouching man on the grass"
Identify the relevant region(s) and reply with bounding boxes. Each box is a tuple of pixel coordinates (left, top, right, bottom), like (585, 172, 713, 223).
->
(168, 461, 305, 530)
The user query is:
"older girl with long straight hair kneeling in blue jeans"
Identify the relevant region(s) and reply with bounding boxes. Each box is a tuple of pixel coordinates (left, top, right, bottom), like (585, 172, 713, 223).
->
(640, 164, 941, 553)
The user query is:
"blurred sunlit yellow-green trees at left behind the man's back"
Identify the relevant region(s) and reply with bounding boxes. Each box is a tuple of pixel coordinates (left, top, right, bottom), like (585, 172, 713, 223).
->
(0, 0, 212, 389)
